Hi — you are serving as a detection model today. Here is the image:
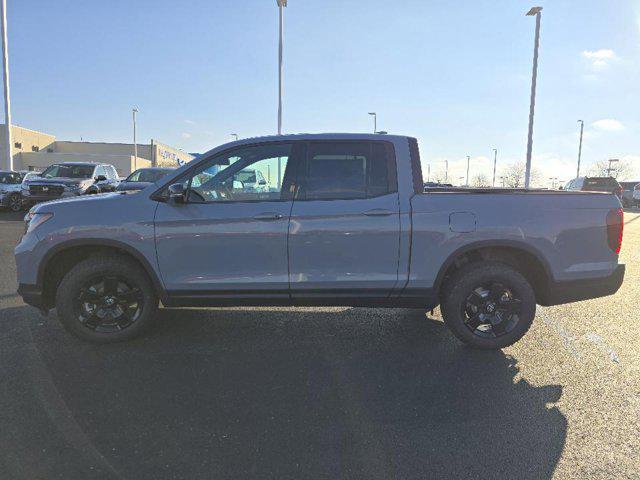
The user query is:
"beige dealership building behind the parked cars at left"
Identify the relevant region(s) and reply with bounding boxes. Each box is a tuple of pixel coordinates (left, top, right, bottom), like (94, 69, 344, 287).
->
(0, 124, 194, 177)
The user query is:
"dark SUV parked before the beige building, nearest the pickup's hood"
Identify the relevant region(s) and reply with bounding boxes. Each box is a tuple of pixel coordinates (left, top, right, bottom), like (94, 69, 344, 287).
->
(22, 162, 119, 205)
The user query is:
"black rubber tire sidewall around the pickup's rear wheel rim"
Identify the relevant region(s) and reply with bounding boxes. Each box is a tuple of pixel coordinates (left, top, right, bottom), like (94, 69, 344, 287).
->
(441, 262, 536, 349)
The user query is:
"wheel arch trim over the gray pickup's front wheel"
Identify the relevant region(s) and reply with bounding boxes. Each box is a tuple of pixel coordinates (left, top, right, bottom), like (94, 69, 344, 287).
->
(37, 240, 165, 306)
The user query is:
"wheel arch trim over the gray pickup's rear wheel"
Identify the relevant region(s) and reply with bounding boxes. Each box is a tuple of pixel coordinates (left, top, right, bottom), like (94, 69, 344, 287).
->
(435, 241, 553, 303)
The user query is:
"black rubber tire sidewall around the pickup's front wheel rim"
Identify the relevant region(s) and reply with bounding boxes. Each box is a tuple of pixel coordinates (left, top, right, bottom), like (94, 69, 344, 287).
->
(56, 256, 158, 343)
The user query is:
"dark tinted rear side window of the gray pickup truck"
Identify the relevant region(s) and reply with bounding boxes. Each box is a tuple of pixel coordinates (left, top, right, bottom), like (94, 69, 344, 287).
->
(299, 142, 398, 200)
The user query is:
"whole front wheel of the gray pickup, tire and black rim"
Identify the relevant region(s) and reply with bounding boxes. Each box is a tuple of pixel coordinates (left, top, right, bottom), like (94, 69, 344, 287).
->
(56, 255, 158, 343)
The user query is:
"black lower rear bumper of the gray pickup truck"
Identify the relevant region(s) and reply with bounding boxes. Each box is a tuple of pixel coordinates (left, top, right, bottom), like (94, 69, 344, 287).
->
(538, 264, 625, 306)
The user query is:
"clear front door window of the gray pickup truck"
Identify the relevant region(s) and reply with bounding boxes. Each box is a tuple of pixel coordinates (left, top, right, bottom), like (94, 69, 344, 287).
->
(185, 144, 294, 203)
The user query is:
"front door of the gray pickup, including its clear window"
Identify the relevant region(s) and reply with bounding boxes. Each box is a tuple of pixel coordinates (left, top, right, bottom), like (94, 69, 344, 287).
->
(155, 143, 295, 299)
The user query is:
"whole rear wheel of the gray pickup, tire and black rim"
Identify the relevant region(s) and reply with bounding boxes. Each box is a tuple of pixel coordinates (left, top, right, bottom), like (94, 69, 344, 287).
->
(440, 261, 536, 350)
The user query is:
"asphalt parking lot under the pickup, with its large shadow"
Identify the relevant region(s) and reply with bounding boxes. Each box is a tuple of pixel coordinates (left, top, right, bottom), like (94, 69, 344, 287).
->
(0, 211, 640, 479)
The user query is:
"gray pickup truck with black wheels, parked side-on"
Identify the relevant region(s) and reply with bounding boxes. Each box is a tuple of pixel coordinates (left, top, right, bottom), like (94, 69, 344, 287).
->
(15, 134, 624, 349)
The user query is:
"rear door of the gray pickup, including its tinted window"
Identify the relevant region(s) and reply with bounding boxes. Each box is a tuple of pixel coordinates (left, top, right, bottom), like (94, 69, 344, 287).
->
(289, 141, 400, 300)
